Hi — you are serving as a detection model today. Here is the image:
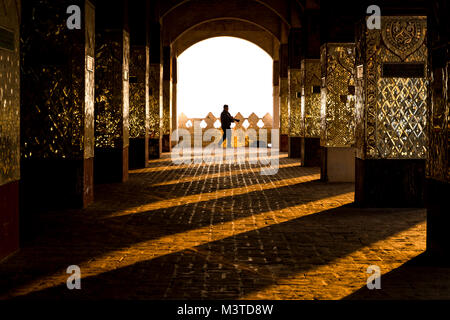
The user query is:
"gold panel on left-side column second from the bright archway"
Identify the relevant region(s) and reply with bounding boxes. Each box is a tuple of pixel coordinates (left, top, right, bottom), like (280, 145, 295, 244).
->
(149, 63, 161, 139)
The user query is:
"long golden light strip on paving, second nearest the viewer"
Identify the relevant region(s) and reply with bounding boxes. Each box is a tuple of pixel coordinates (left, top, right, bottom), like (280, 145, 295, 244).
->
(9, 192, 354, 296)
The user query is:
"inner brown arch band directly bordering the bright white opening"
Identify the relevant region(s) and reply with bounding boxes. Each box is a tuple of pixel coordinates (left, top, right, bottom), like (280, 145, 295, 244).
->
(172, 19, 279, 59)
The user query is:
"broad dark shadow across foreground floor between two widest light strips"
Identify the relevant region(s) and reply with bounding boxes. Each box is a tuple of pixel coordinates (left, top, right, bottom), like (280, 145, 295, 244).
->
(9, 206, 425, 300)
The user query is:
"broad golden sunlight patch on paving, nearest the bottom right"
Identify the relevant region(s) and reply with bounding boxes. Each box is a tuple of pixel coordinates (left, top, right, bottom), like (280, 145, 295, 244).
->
(243, 221, 426, 300)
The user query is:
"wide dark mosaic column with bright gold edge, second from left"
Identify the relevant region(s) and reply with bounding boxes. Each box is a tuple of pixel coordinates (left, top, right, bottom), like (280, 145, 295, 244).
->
(21, 0, 96, 219)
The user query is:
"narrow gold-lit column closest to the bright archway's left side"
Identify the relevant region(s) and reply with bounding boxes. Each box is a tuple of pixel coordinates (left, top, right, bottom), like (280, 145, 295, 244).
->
(160, 47, 172, 152)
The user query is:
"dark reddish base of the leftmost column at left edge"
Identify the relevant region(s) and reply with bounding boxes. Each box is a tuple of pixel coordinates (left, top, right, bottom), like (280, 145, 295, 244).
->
(0, 181, 19, 261)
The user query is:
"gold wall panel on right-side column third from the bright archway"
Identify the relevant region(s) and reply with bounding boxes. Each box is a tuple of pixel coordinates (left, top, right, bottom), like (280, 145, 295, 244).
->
(301, 59, 321, 138)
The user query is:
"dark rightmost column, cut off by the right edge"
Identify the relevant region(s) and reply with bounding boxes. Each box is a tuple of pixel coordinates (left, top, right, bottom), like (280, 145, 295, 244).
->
(426, 0, 450, 261)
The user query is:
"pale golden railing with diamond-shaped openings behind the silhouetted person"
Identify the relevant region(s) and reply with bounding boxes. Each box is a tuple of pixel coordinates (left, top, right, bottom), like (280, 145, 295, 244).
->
(178, 112, 273, 147)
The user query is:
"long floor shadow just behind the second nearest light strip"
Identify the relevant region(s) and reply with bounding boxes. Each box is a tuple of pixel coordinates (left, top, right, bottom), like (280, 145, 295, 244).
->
(0, 181, 353, 294)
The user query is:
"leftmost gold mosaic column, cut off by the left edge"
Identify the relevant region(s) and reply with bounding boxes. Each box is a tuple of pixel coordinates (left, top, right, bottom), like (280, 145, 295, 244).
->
(0, 0, 21, 260)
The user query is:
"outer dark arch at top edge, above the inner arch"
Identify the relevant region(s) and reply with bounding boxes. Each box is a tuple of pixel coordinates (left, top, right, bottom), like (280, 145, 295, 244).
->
(161, 0, 289, 46)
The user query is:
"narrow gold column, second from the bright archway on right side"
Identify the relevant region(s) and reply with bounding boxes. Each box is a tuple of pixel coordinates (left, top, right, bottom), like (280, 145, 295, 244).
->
(288, 28, 302, 158)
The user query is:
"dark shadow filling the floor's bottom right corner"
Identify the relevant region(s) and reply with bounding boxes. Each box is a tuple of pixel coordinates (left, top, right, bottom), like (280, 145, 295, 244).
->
(344, 253, 450, 300)
